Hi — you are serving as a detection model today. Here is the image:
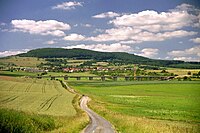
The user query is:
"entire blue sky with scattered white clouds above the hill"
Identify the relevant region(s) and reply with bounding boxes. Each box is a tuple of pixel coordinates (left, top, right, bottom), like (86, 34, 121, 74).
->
(0, 0, 200, 61)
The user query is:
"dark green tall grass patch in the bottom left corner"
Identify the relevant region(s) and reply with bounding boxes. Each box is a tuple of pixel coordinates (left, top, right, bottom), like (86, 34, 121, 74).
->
(0, 109, 55, 133)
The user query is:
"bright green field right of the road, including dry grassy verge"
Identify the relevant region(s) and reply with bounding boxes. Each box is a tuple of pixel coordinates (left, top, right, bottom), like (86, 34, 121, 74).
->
(69, 81, 200, 132)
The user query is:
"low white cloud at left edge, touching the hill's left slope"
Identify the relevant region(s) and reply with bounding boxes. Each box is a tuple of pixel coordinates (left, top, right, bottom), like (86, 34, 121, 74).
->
(0, 49, 29, 57)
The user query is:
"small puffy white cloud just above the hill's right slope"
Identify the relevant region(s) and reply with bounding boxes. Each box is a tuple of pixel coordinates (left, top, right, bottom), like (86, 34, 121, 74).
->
(138, 48, 159, 58)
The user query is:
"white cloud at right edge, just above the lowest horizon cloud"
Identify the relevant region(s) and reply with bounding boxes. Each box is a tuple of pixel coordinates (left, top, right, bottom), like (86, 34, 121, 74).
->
(168, 46, 200, 57)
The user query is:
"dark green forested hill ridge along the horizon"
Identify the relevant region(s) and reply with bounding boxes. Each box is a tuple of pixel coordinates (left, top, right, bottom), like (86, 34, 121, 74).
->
(18, 48, 200, 68)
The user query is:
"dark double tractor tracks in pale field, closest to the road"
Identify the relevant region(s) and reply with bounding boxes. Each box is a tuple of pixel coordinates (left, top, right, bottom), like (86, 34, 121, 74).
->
(39, 94, 61, 111)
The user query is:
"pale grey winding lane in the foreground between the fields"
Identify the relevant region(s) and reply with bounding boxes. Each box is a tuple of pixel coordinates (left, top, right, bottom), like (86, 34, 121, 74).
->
(80, 96, 115, 133)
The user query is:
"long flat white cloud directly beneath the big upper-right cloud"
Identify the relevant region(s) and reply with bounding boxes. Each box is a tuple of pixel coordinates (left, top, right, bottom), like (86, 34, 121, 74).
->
(88, 27, 197, 43)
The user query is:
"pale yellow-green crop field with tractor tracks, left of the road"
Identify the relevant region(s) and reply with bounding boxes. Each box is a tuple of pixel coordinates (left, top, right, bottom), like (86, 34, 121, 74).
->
(0, 77, 76, 116)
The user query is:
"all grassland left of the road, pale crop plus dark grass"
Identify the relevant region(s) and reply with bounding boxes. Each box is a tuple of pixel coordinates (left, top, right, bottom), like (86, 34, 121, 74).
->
(0, 76, 89, 132)
